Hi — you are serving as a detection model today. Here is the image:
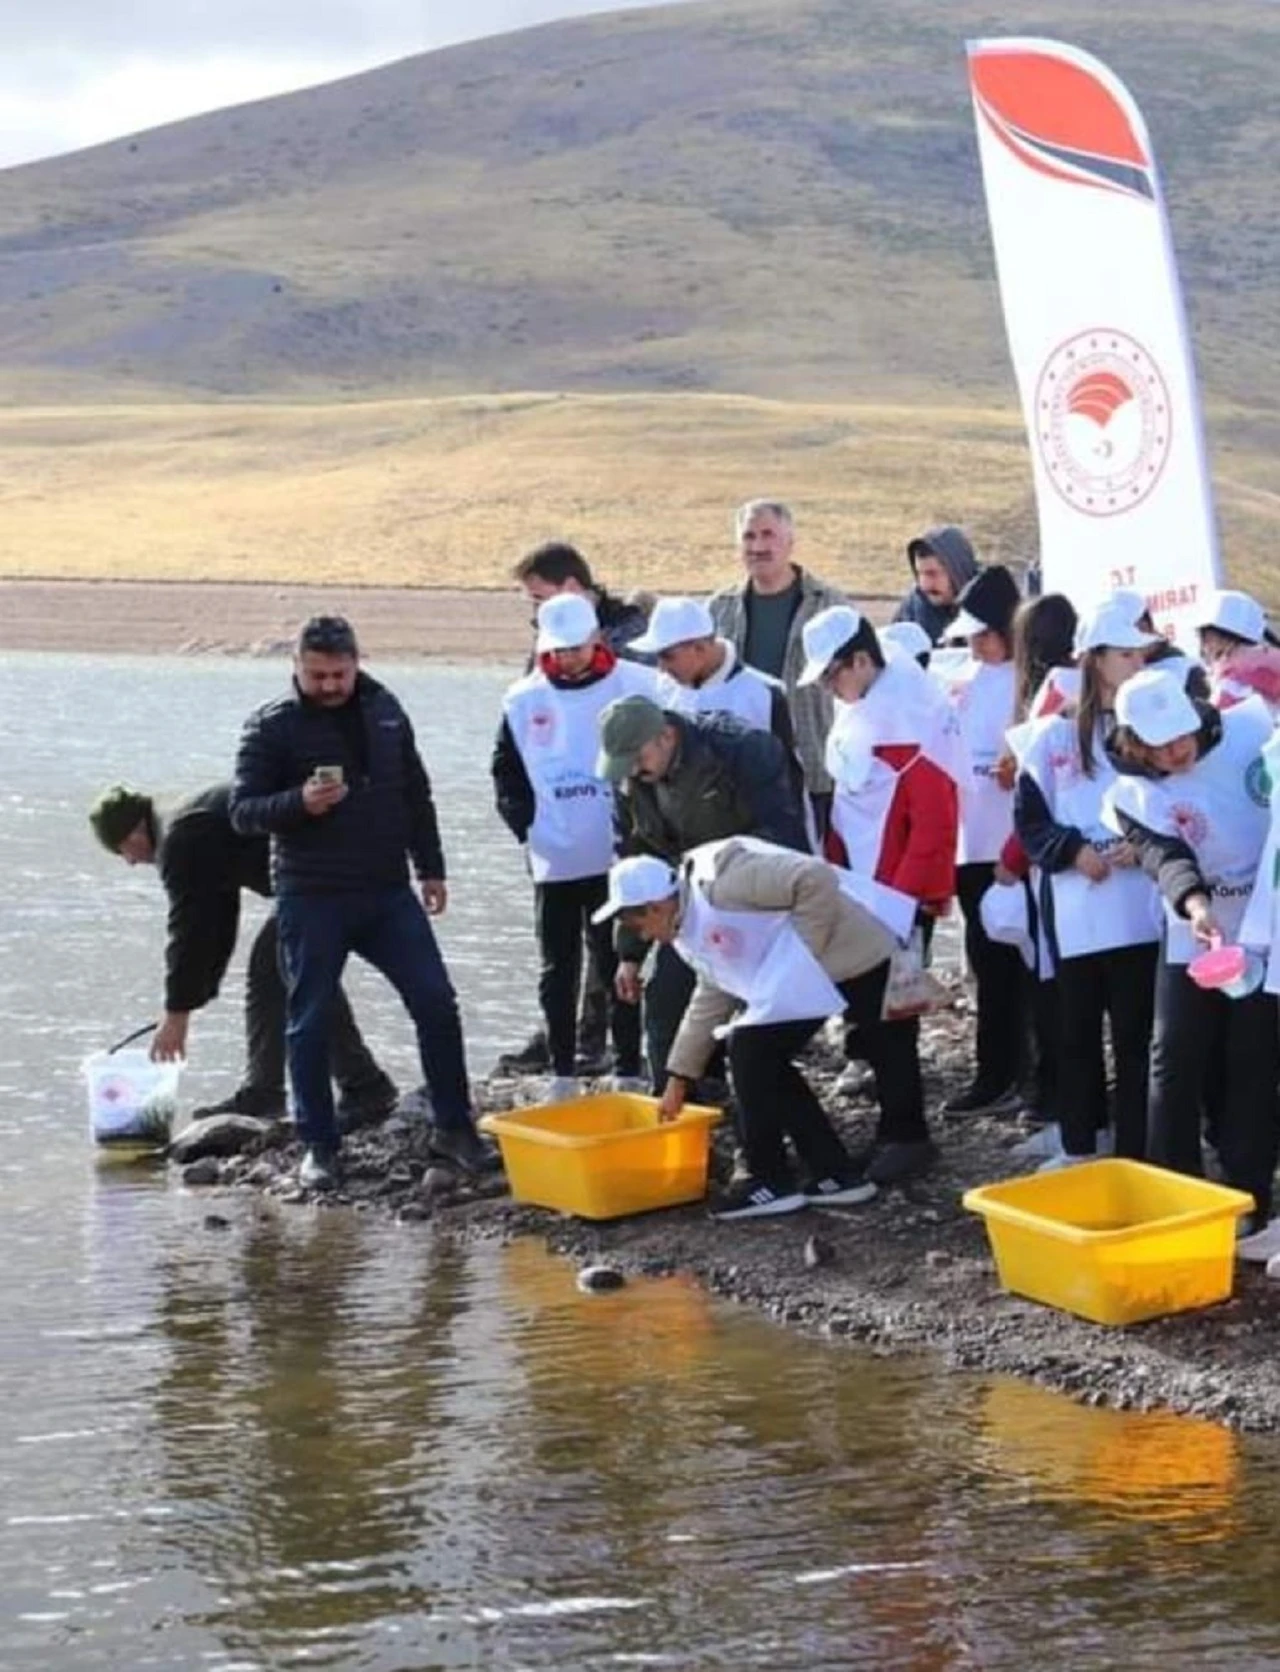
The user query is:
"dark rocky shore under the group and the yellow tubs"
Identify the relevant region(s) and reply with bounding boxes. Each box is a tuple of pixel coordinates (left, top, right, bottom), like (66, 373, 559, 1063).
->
(175, 991, 1280, 1431)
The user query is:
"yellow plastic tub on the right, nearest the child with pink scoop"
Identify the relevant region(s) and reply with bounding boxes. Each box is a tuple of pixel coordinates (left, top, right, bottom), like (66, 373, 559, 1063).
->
(964, 1160, 1253, 1324)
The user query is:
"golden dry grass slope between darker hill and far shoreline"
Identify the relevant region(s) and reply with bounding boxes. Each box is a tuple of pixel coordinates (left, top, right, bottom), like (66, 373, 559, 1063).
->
(0, 395, 1280, 595)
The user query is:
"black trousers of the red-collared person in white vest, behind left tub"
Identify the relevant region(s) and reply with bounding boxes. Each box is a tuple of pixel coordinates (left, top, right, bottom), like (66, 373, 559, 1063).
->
(533, 876, 640, 1075)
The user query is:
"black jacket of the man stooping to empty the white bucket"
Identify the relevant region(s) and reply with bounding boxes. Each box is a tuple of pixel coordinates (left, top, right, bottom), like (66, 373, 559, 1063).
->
(155, 784, 271, 1012)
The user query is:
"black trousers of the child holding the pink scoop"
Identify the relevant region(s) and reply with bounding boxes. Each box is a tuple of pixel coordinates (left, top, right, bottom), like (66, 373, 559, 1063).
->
(1148, 956, 1280, 1221)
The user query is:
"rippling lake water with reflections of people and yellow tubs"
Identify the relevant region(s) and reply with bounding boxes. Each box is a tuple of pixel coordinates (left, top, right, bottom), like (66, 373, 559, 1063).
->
(0, 655, 1280, 1672)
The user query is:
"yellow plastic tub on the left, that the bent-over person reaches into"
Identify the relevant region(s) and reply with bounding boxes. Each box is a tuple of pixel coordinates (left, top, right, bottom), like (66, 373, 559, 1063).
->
(480, 1092, 720, 1219)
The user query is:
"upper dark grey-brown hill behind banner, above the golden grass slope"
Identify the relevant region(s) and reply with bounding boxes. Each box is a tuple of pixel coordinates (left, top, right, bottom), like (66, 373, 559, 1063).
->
(0, 0, 1280, 406)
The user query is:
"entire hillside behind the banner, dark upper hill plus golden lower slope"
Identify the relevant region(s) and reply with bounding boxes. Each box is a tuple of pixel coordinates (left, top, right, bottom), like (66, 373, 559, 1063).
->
(0, 0, 1280, 595)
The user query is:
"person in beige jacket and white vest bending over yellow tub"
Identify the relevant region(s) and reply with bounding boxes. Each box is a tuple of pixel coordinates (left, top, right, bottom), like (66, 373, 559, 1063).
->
(597, 836, 894, 1219)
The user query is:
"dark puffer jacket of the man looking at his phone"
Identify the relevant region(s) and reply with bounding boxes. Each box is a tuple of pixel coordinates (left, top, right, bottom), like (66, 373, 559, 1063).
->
(231, 674, 444, 895)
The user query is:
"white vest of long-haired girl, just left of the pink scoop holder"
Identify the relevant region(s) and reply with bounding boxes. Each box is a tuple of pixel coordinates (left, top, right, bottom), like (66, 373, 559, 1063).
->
(1018, 716, 1160, 958)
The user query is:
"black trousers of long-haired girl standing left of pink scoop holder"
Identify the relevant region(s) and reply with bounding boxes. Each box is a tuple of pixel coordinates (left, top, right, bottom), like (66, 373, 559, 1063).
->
(1056, 941, 1163, 1160)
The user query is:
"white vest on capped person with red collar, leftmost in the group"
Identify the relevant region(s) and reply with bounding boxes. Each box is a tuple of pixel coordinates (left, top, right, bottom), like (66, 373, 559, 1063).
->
(503, 662, 655, 883)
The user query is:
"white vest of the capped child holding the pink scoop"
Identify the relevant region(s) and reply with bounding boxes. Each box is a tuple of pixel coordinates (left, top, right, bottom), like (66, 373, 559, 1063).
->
(1103, 699, 1272, 963)
